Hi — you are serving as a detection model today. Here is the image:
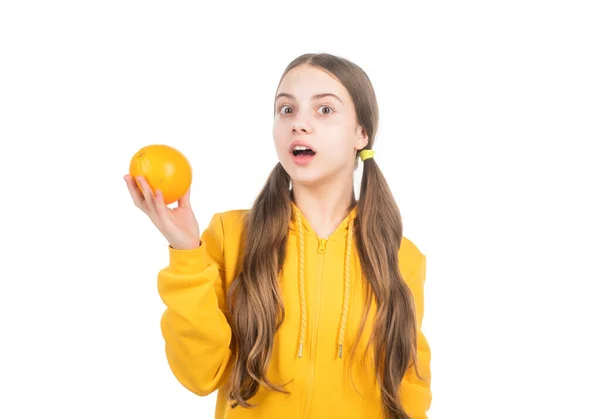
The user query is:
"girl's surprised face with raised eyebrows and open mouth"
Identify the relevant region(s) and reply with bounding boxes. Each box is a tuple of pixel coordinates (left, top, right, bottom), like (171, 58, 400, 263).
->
(273, 65, 368, 184)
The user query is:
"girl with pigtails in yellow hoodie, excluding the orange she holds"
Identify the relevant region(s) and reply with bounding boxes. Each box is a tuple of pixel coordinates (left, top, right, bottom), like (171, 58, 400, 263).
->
(126, 54, 431, 419)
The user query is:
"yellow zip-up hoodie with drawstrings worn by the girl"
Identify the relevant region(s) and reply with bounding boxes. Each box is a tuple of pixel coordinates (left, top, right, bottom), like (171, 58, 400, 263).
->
(158, 203, 431, 419)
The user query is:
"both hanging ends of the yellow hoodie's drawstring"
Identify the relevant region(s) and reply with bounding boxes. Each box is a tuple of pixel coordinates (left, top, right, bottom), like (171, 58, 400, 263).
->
(295, 210, 354, 358)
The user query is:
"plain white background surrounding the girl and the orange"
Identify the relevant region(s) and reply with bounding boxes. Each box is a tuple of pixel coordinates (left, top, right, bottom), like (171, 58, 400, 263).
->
(0, 0, 600, 419)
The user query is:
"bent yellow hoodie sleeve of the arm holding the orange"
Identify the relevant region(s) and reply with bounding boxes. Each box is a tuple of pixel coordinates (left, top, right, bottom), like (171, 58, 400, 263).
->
(158, 214, 232, 396)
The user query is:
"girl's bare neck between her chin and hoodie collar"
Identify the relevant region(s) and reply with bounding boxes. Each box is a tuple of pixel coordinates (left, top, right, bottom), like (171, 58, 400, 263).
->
(292, 176, 356, 238)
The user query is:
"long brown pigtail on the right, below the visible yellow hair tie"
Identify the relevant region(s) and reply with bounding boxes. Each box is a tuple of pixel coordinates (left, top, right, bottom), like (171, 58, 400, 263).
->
(351, 154, 418, 419)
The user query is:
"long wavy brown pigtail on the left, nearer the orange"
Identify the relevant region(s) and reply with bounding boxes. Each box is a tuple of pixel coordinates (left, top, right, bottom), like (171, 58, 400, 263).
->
(228, 163, 291, 407)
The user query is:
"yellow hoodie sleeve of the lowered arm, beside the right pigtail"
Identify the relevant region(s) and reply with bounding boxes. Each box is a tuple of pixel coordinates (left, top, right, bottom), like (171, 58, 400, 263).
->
(400, 255, 431, 419)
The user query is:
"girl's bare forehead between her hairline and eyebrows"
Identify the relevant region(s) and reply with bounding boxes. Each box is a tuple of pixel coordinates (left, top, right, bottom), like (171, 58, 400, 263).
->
(277, 64, 348, 99)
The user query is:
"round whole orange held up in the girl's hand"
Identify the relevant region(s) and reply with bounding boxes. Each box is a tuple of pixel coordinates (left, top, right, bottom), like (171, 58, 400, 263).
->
(129, 144, 192, 205)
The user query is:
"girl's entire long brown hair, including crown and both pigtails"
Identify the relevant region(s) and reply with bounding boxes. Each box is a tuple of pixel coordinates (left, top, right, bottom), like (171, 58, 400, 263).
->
(228, 54, 418, 419)
